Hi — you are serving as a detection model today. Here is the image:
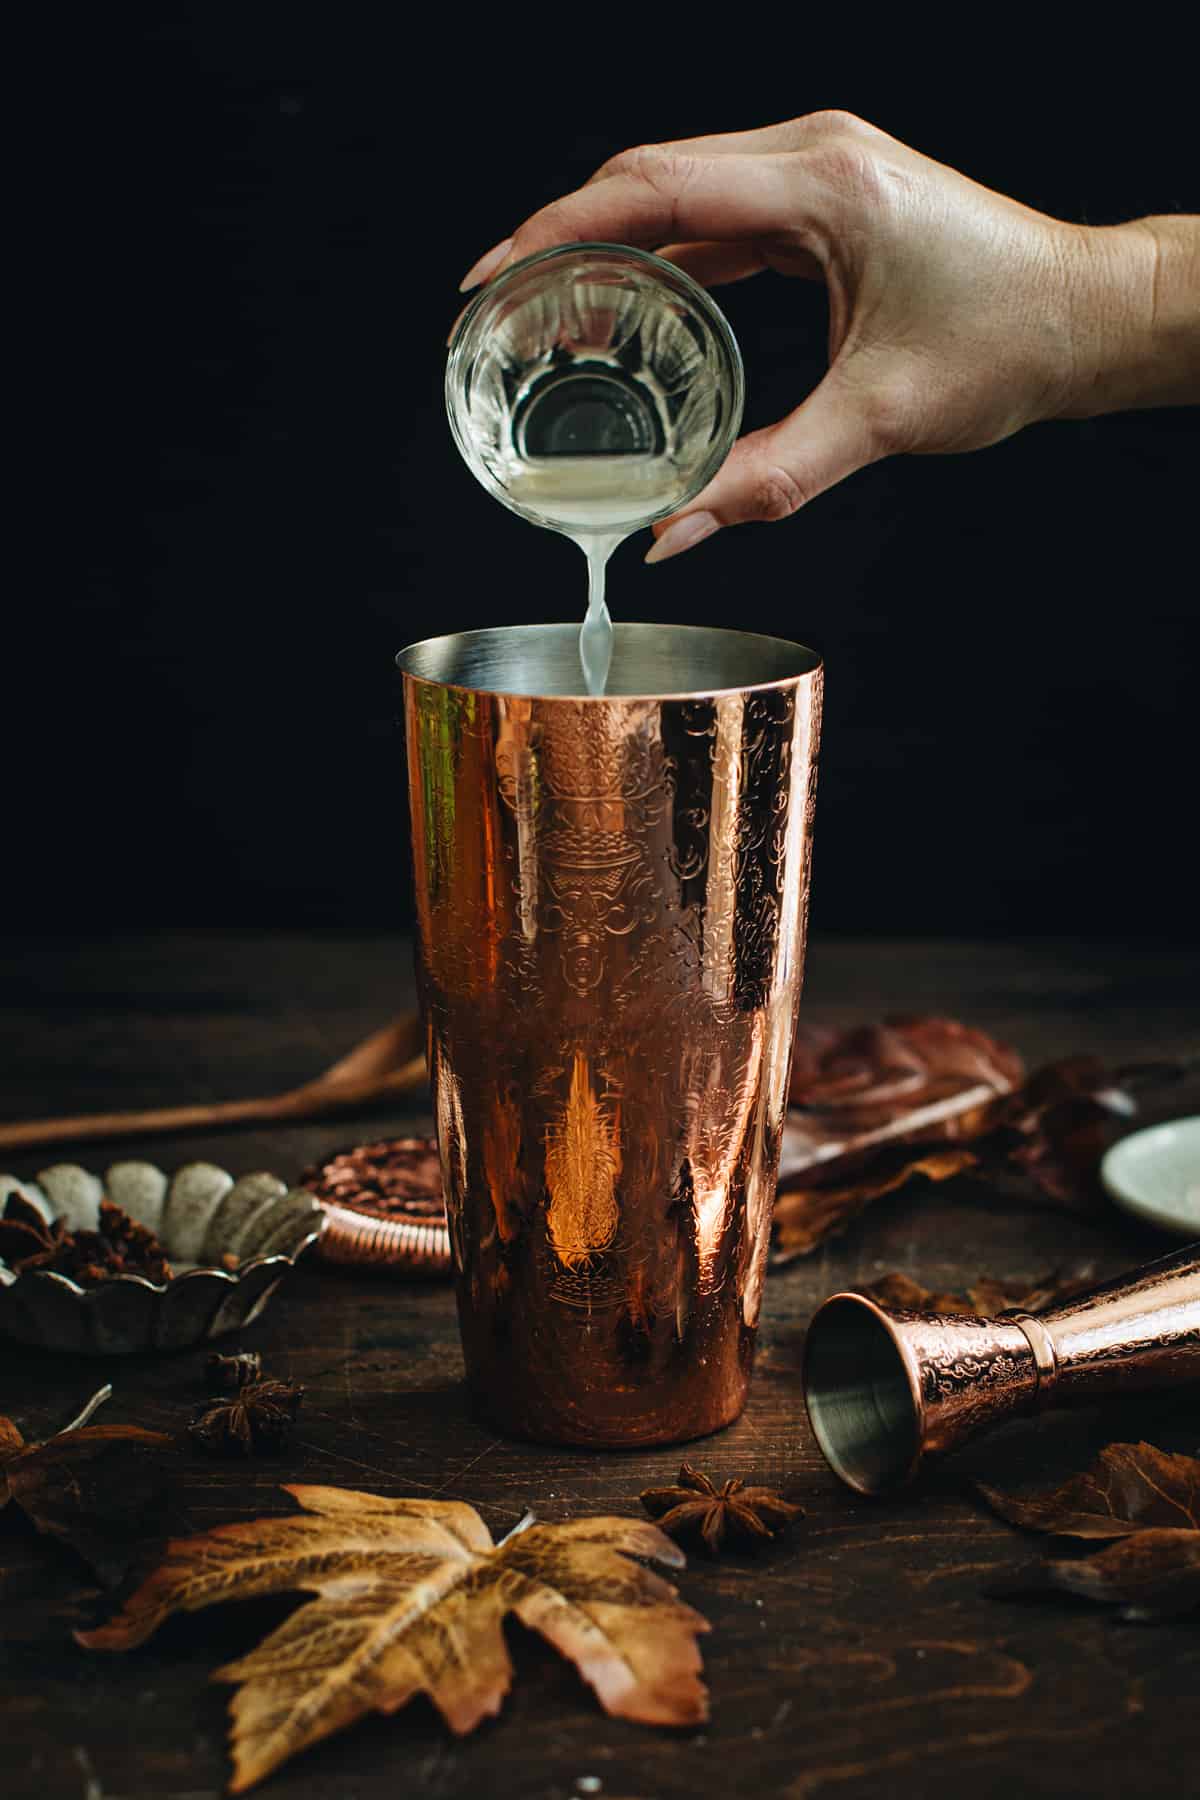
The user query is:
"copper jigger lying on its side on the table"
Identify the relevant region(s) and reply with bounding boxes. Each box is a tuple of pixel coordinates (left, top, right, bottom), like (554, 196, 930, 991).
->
(802, 1244, 1200, 1494)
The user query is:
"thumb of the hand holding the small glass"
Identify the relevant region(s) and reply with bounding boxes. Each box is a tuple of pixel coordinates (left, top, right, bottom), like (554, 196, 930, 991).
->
(646, 369, 883, 562)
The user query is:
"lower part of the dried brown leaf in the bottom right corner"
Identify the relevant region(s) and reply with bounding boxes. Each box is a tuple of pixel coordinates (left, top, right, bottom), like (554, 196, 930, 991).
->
(990, 1526, 1200, 1624)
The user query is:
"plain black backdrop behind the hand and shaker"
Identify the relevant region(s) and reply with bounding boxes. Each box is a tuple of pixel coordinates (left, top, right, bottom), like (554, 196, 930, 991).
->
(14, 7, 1200, 934)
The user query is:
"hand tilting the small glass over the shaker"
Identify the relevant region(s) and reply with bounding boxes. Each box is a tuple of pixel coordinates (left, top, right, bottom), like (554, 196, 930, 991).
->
(462, 113, 1195, 562)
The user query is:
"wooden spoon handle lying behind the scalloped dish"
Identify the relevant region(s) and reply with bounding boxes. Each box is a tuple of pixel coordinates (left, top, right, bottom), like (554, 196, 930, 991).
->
(0, 1055, 425, 1150)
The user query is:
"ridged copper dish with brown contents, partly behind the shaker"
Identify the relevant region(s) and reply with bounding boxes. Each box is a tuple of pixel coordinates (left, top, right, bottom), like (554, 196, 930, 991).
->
(300, 1138, 450, 1278)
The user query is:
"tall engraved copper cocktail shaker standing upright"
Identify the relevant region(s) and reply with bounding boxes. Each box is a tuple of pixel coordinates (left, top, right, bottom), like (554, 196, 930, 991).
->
(398, 625, 822, 1445)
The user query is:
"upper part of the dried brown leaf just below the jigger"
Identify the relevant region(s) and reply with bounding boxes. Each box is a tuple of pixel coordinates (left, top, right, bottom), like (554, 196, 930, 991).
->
(979, 1444, 1200, 1541)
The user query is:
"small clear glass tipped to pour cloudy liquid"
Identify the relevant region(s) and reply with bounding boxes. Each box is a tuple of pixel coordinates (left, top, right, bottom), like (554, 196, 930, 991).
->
(446, 243, 745, 553)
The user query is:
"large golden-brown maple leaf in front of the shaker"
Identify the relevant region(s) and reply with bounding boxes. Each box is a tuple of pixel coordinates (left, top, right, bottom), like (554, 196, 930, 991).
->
(76, 1485, 709, 1793)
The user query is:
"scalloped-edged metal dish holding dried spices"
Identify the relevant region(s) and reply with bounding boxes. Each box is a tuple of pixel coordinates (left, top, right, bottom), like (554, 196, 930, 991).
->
(0, 1163, 324, 1355)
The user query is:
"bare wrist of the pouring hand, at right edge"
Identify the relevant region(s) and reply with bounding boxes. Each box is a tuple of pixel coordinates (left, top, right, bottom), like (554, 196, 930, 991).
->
(1056, 216, 1200, 419)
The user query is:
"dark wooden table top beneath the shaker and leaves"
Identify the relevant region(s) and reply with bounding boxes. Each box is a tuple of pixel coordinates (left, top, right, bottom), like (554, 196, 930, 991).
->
(0, 934, 1200, 1800)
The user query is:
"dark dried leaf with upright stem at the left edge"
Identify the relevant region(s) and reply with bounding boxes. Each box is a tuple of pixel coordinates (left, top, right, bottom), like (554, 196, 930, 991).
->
(0, 1388, 175, 1584)
